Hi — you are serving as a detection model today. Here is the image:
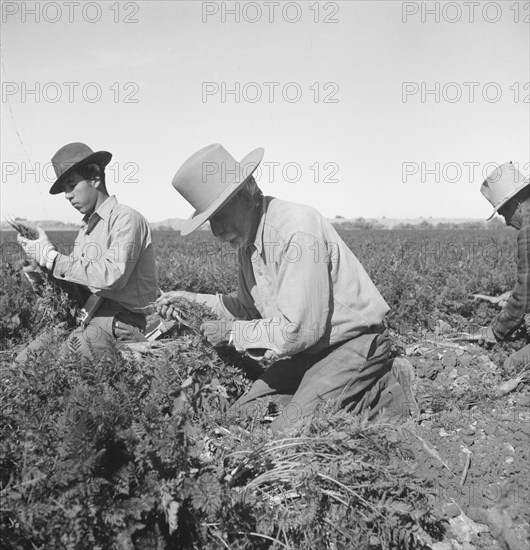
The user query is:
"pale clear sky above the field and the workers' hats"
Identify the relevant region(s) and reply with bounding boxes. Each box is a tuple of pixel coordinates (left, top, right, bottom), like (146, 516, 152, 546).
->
(1, 0, 530, 222)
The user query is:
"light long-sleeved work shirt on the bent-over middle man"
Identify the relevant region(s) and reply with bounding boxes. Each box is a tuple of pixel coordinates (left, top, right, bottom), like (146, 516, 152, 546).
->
(197, 197, 389, 362)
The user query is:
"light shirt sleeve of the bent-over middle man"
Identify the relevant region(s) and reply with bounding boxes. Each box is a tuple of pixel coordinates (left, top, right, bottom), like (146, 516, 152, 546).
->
(234, 232, 331, 359)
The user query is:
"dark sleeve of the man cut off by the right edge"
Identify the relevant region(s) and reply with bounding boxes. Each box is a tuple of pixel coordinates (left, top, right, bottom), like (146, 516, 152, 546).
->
(492, 226, 530, 340)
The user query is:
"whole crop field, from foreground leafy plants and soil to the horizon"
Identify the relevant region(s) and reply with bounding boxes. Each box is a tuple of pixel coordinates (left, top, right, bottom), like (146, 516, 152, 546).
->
(0, 226, 530, 550)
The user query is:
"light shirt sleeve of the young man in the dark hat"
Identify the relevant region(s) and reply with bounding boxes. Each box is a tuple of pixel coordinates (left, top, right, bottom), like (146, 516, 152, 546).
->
(53, 211, 149, 291)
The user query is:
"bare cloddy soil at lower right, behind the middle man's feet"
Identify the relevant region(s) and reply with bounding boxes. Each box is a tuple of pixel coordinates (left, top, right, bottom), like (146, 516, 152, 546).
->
(394, 333, 530, 550)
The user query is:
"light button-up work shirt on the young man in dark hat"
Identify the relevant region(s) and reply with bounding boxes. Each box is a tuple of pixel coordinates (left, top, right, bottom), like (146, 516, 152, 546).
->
(53, 195, 158, 314)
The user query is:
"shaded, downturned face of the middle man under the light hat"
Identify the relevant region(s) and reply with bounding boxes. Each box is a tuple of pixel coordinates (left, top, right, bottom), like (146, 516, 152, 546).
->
(210, 194, 252, 249)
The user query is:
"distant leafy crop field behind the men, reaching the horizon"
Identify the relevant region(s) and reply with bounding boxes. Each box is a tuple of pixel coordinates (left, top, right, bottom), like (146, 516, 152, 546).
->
(0, 230, 516, 348)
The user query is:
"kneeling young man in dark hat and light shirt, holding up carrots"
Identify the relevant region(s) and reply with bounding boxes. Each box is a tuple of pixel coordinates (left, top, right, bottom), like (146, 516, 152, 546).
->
(16, 143, 157, 362)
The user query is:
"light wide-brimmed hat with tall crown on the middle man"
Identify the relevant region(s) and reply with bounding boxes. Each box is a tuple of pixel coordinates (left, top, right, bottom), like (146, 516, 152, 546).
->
(171, 143, 265, 235)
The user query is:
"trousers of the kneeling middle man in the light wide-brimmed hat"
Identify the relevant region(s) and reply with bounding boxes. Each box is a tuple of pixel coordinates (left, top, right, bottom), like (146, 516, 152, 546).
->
(229, 331, 406, 434)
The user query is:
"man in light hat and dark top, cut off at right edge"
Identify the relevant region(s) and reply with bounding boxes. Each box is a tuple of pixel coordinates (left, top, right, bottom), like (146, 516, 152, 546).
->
(480, 162, 530, 370)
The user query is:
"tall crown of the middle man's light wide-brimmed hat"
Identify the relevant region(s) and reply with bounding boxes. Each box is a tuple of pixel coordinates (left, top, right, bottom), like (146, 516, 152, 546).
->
(171, 143, 256, 213)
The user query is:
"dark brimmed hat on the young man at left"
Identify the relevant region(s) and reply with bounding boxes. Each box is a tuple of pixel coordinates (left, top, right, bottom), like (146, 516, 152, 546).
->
(50, 143, 112, 195)
